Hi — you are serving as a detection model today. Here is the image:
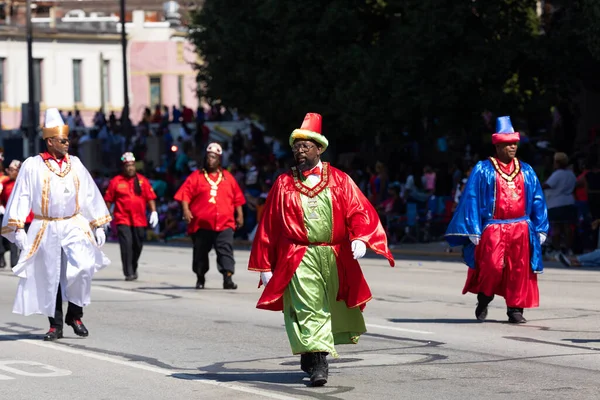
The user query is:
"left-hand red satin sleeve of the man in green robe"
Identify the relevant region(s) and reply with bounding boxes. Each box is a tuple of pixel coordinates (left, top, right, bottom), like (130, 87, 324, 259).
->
(248, 179, 283, 276)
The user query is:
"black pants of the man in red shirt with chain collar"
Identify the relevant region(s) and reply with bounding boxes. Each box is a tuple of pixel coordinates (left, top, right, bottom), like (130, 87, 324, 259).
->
(192, 229, 235, 278)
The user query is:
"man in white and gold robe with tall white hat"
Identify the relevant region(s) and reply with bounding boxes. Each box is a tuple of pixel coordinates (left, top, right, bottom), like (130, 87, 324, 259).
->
(2, 109, 111, 341)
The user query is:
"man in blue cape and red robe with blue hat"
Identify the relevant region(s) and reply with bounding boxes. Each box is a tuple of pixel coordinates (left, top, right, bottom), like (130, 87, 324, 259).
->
(446, 117, 548, 323)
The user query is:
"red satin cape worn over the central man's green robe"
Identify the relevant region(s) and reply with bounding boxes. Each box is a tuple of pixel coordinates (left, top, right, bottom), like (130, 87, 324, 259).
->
(248, 165, 395, 311)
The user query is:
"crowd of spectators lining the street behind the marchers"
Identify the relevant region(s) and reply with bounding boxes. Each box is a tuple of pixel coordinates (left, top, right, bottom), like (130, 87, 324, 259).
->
(50, 105, 600, 257)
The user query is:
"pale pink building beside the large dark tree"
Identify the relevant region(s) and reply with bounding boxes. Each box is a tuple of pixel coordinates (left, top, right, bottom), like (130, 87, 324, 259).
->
(127, 11, 198, 124)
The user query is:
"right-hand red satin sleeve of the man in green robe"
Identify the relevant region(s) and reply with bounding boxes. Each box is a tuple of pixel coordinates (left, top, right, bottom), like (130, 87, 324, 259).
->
(342, 175, 395, 266)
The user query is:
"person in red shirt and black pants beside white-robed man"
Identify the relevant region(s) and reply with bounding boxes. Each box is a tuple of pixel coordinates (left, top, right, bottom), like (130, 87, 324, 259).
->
(104, 152, 158, 281)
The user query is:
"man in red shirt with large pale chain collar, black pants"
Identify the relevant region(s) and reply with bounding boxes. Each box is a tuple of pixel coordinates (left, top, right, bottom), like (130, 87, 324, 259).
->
(175, 143, 246, 289)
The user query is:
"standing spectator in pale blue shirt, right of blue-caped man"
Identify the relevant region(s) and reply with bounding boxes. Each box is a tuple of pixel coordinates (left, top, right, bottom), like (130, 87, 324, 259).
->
(542, 153, 577, 255)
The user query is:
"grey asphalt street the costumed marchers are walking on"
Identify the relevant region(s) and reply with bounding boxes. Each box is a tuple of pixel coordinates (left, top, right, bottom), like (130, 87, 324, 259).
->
(0, 244, 600, 400)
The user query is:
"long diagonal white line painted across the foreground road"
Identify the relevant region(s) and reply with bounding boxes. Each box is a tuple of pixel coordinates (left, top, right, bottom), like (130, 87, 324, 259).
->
(19, 339, 296, 400)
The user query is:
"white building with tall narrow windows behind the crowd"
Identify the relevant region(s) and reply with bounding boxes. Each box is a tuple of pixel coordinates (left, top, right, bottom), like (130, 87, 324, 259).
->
(0, 27, 124, 129)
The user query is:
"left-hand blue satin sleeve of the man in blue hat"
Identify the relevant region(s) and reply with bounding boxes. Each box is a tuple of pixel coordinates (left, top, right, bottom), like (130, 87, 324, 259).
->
(446, 163, 484, 247)
